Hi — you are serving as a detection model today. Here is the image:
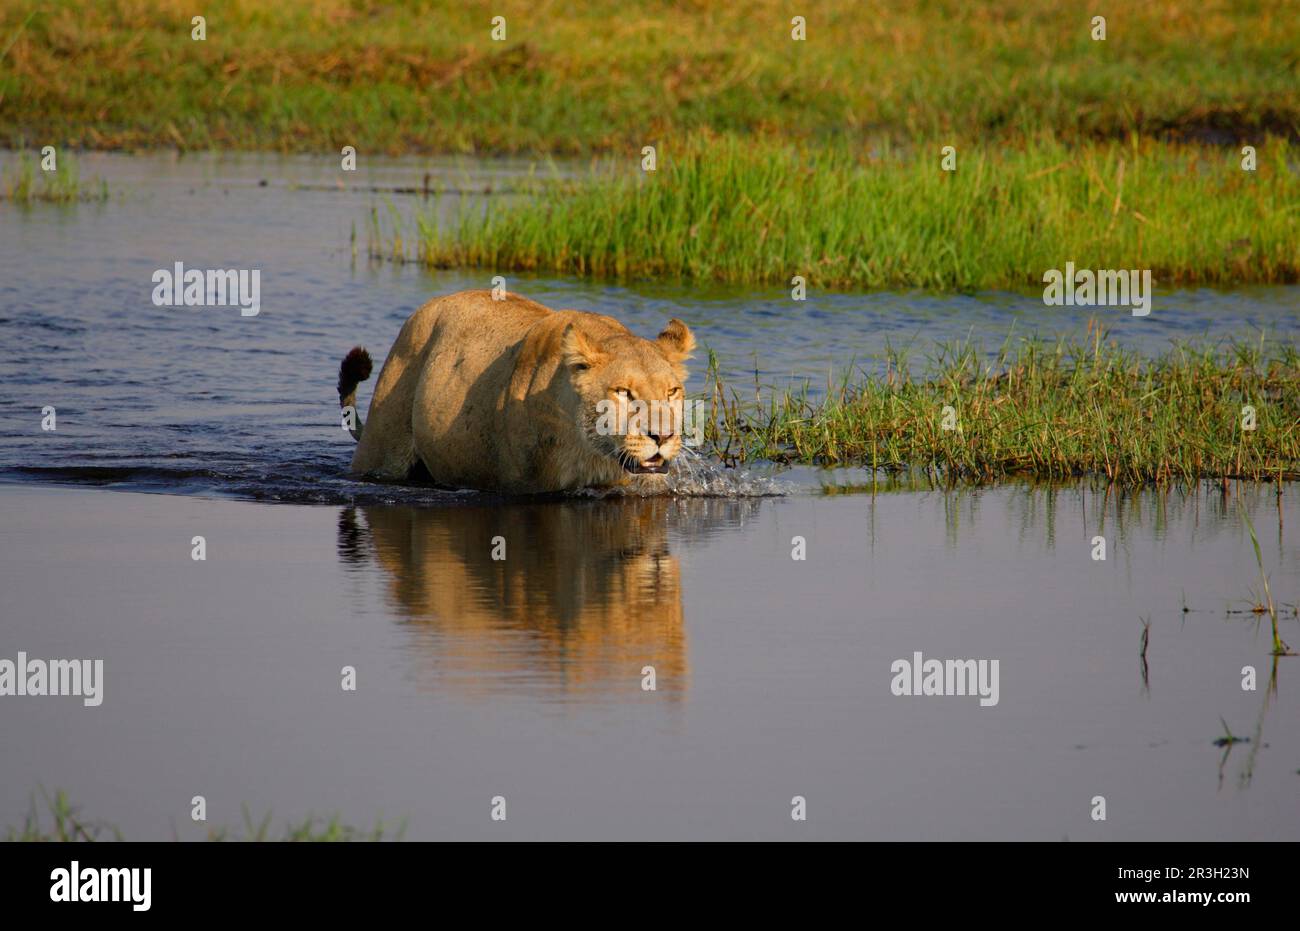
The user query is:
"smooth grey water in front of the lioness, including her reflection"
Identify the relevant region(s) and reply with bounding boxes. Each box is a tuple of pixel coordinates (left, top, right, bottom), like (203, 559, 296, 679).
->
(0, 486, 1300, 840)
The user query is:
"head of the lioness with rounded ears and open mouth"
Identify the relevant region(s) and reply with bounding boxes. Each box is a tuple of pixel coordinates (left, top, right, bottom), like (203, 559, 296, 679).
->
(562, 319, 696, 475)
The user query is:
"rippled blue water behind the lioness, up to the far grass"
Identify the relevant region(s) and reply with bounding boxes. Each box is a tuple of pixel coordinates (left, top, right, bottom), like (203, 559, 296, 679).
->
(0, 153, 1300, 501)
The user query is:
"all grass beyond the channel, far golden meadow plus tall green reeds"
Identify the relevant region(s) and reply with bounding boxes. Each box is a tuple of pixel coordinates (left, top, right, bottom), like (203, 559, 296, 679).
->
(10, 0, 1300, 290)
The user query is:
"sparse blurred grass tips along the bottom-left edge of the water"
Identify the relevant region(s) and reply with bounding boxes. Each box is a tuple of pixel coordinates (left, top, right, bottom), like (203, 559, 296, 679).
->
(4, 789, 406, 843)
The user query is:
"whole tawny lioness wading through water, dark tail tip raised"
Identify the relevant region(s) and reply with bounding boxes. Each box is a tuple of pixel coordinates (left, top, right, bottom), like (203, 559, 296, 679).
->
(338, 291, 696, 493)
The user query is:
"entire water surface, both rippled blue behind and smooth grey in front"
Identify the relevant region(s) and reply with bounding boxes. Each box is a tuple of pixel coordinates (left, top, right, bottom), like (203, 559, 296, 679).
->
(0, 150, 1300, 840)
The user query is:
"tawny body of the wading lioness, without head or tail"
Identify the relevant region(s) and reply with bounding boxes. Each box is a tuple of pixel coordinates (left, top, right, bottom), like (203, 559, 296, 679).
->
(352, 291, 628, 490)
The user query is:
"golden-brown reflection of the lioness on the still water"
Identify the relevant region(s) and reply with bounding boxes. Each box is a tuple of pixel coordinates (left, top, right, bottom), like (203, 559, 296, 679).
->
(339, 497, 746, 700)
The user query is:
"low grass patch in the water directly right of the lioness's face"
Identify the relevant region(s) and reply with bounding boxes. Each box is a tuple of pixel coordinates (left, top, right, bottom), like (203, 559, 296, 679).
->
(705, 328, 1300, 485)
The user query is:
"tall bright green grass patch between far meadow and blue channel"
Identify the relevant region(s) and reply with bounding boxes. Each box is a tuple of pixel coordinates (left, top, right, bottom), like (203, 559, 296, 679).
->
(403, 134, 1300, 290)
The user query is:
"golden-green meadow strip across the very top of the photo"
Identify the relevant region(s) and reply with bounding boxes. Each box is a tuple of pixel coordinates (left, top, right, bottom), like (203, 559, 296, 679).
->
(0, 0, 1300, 156)
